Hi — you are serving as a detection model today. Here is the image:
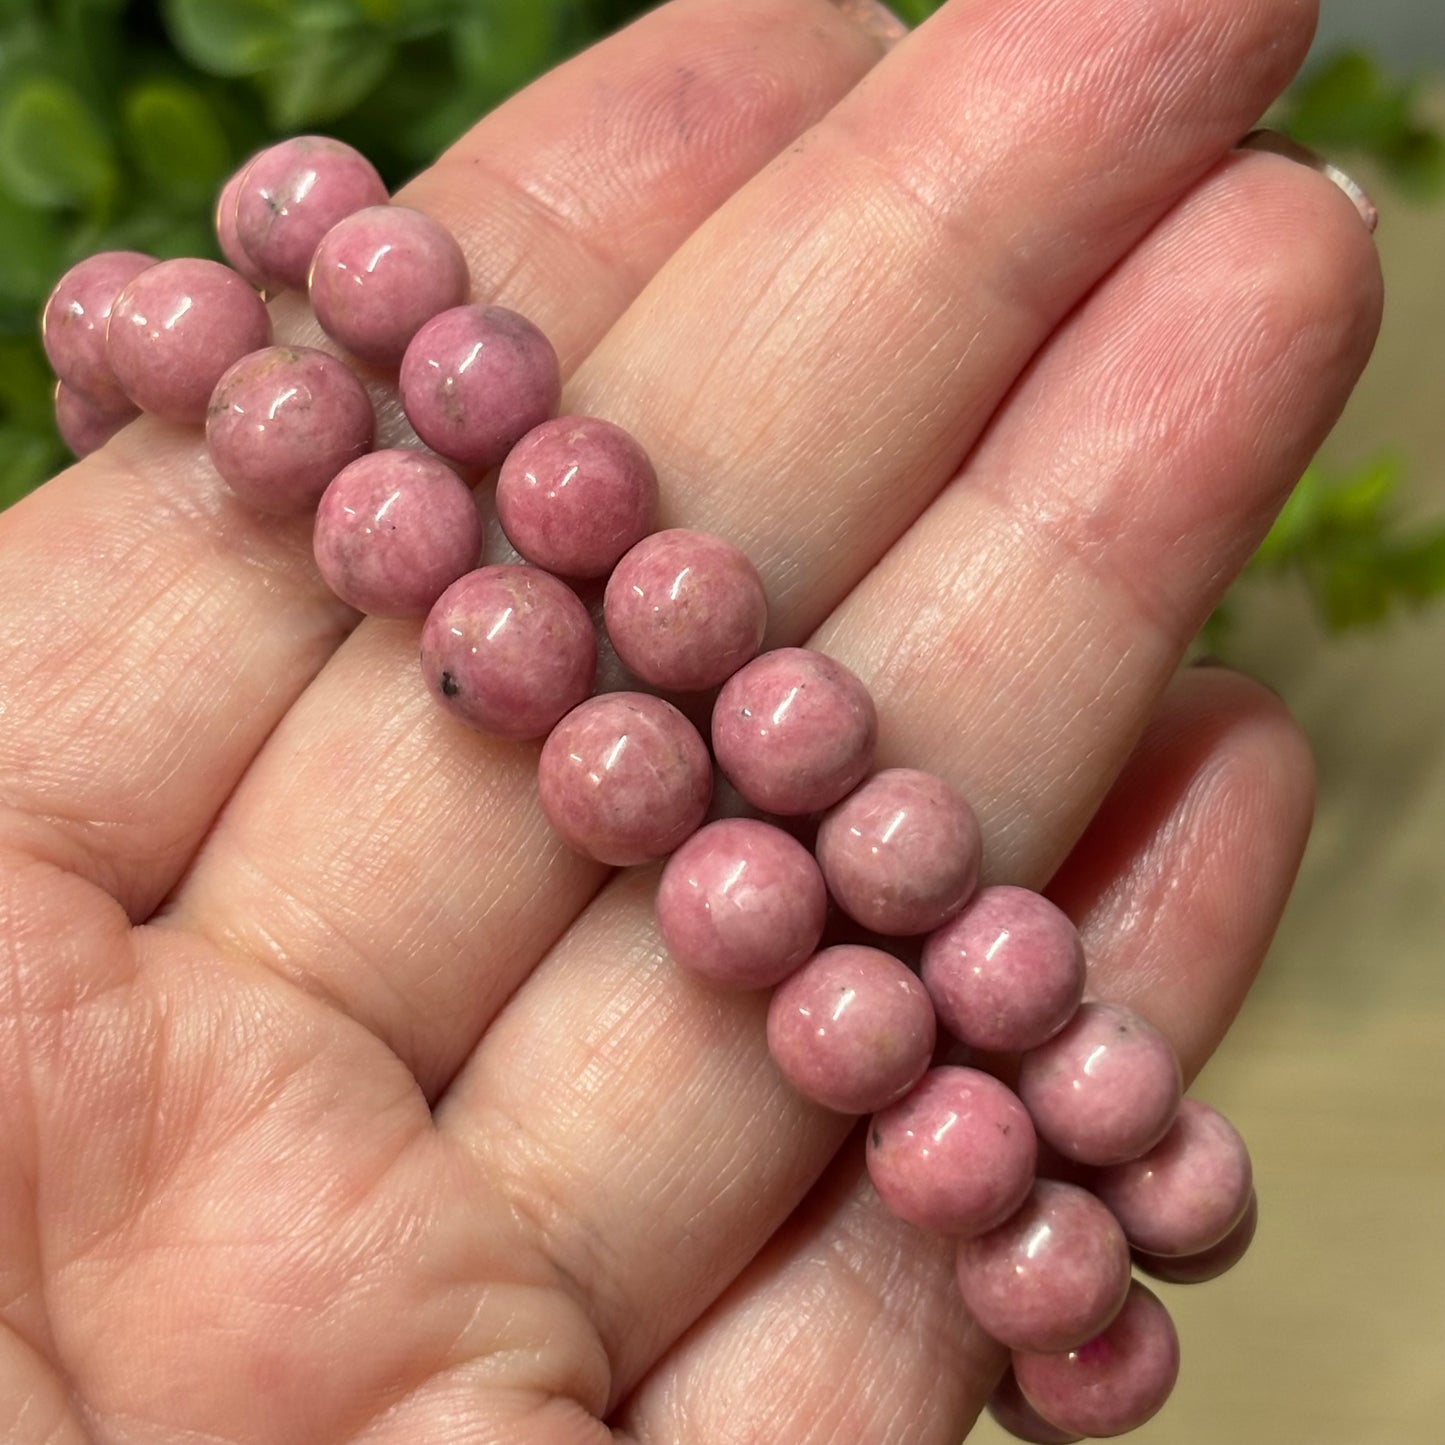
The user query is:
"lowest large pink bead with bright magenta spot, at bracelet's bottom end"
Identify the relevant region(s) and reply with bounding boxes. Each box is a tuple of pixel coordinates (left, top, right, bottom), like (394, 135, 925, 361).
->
(1013, 1283, 1179, 1436)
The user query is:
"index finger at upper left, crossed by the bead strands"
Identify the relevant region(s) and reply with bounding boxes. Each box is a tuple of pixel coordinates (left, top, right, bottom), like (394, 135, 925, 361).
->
(0, 0, 879, 918)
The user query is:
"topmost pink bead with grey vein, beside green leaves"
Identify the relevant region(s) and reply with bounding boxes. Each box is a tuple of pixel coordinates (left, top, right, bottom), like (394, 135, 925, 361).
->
(236, 136, 387, 290)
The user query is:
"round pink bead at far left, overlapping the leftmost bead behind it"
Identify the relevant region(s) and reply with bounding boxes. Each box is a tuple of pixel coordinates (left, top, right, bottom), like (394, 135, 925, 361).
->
(105, 257, 270, 425)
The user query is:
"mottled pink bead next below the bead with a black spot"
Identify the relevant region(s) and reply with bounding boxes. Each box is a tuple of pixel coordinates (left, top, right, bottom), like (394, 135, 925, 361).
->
(538, 692, 712, 867)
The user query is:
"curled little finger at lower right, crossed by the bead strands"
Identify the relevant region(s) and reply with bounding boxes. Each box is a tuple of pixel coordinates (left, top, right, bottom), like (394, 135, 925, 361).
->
(618, 669, 1314, 1445)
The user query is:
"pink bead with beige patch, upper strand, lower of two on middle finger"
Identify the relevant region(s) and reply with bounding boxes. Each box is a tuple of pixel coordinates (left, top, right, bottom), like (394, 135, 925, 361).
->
(604, 527, 767, 692)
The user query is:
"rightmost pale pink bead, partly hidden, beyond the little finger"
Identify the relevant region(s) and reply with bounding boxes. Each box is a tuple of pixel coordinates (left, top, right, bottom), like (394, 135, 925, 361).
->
(1090, 1098, 1253, 1254)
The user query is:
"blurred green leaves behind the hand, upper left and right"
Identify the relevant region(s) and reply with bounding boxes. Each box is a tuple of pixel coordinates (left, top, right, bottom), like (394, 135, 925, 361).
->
(0, 0, 1445, 632)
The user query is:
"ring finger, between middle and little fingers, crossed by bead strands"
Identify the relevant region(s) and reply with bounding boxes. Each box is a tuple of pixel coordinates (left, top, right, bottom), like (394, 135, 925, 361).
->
(441, 140, 1379, 1380)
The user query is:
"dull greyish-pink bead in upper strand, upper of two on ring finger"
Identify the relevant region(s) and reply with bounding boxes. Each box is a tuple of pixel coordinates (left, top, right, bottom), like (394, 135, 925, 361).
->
(818, 767, 983, 938)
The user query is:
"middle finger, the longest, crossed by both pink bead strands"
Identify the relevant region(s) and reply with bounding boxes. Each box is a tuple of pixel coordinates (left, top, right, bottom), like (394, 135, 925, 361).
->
(181, 0, 1303, 1092)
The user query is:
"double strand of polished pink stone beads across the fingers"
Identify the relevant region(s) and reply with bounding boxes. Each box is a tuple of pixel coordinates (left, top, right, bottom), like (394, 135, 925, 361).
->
(43, 136, 1256, 1442)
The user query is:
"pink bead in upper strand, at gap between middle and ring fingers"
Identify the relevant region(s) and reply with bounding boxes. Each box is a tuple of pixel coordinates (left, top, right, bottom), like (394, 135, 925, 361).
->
(712, 647, 879, 816)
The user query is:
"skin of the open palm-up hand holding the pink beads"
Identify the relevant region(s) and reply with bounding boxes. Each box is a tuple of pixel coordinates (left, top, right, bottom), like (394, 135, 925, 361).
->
(0, 0, 1379, 1445)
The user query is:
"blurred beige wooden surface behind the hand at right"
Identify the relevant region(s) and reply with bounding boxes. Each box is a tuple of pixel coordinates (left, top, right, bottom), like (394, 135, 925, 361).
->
(970, 130, 1445, 1445)
